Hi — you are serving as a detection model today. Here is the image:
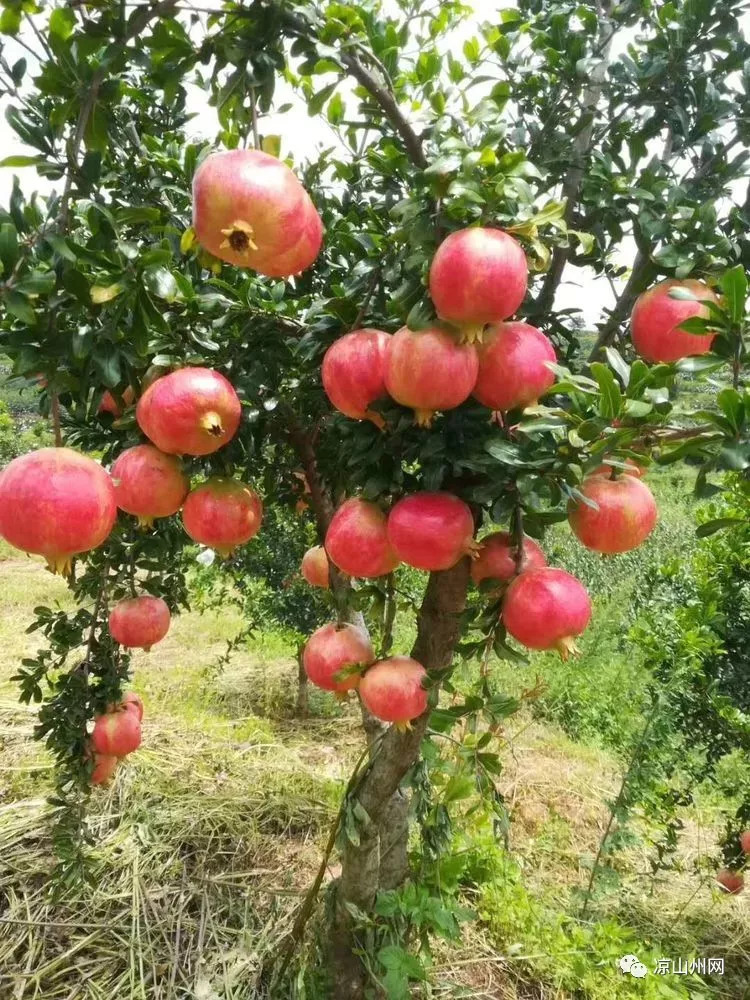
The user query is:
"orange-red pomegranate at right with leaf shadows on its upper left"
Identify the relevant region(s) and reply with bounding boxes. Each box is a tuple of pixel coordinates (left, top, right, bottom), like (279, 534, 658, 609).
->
(568, 474, 659, 555)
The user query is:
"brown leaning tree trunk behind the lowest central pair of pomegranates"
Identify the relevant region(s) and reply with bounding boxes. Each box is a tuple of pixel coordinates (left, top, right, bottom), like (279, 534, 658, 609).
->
(331, 559, 469, 1000)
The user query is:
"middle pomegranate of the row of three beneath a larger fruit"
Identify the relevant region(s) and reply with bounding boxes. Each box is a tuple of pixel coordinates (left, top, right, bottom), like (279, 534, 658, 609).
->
(385, 326, 479, 427)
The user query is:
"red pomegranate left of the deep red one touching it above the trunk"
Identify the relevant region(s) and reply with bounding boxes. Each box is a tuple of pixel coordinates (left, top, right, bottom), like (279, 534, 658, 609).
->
(326, 498, 399, 578)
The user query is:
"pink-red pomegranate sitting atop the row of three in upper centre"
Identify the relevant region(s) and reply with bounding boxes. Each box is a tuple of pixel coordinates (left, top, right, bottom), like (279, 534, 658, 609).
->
(429, 227, 529, 342)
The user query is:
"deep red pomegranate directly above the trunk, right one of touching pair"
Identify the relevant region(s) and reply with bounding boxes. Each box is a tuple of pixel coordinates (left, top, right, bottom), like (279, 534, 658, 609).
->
(388, 492, 479, 571)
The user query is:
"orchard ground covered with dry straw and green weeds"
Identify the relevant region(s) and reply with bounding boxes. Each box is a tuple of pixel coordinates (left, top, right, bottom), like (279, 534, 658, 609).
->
(0, 469, 750, 1000)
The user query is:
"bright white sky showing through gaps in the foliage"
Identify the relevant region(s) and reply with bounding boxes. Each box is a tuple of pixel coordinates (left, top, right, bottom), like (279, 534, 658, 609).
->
(0, 0, 716, 328)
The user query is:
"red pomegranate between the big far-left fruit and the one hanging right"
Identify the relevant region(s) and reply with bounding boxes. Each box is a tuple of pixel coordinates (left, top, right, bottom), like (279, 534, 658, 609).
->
(112, 444, 190, 527)
